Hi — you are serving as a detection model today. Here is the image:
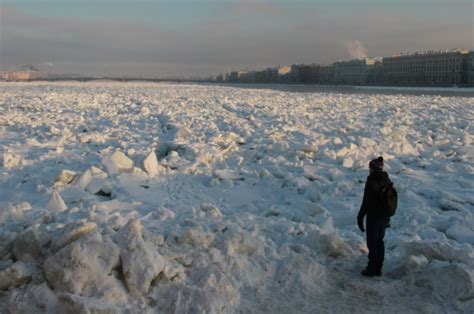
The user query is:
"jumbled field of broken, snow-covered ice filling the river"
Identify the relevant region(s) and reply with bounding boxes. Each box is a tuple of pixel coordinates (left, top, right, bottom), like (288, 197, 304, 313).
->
(0, 82, 474, 313)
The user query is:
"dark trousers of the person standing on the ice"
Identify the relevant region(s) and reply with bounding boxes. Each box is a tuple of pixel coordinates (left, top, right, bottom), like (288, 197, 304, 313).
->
(366, 216, 388, 273)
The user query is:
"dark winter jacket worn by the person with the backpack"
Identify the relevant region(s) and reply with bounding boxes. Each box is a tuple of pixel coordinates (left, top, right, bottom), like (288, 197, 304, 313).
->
(357, 171, 392, 219)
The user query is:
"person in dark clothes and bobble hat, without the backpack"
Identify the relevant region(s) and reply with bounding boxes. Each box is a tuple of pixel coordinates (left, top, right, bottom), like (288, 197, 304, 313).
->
(357, 157, 392, 277)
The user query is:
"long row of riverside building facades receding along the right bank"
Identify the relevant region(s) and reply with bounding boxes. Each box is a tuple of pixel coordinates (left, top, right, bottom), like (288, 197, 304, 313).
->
(219, 49, 474, 86)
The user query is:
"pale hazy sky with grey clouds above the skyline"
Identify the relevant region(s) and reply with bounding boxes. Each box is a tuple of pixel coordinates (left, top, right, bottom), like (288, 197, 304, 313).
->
(0, 0, 474, 77)
